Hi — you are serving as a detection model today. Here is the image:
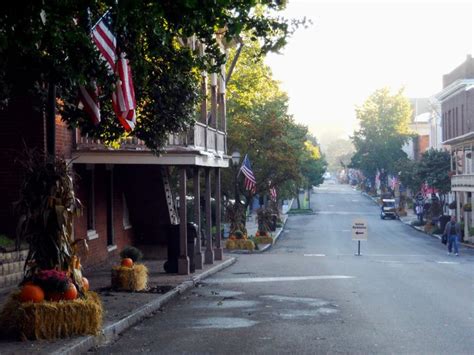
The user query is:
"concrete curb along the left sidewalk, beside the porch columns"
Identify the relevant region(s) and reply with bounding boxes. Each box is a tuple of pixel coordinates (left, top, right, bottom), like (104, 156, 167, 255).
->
(52, 257, 237, 355)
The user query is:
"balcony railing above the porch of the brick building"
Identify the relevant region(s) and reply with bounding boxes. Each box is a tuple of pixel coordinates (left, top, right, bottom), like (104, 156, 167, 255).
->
(75, 122, 226, 154)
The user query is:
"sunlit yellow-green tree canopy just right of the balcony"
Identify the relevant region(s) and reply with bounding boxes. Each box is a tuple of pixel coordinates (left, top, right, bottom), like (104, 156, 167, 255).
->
(223, 41, 325, 201)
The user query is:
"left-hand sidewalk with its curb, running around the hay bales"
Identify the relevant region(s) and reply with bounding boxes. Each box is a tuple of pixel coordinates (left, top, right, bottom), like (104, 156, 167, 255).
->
(0, 207, 288, 355)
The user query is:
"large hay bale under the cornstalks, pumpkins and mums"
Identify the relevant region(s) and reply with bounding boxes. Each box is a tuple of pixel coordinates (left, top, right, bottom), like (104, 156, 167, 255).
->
(0, 291, 103, 340)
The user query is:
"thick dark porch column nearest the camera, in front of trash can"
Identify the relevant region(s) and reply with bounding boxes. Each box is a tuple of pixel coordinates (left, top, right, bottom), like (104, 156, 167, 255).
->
(178, 166, 189, 275)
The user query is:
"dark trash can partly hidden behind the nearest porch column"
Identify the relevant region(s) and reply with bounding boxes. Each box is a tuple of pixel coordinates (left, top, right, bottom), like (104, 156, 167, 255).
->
(164, 222, 197, 273)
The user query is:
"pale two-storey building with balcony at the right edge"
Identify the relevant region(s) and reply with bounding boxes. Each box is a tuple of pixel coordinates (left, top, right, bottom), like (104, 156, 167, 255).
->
(436, 55, 474, 241)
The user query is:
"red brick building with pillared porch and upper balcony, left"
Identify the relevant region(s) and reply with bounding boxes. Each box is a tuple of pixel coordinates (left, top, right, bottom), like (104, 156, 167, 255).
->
(0, 47, 229, 274)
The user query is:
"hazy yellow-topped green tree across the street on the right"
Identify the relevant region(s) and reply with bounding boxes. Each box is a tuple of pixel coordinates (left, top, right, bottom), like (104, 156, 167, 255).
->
(351, 88, 411, 186)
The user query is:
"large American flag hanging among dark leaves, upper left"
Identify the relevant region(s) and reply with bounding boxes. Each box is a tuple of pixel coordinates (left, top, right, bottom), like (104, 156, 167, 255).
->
(80, 11, 136, 132)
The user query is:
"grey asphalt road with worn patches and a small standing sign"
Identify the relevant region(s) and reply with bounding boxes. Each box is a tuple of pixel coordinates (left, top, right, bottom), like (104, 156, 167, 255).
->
(95, 184, 474, 354)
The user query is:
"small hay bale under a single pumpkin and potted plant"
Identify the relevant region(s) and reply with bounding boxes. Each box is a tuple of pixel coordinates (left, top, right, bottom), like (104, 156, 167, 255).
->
(112, 264, 148, 291)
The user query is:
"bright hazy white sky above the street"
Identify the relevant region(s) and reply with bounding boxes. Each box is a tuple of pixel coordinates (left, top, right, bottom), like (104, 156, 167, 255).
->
(266, 0, 474, 146)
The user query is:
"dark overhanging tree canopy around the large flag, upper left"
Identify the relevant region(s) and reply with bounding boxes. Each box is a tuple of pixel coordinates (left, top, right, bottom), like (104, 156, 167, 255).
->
(0, 0, 298, 150)
